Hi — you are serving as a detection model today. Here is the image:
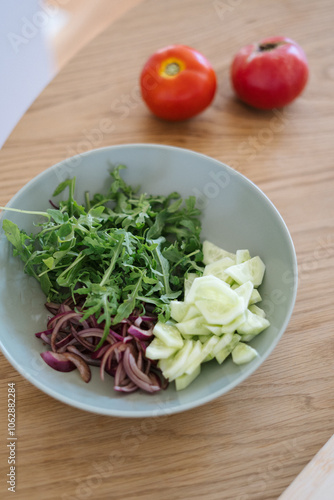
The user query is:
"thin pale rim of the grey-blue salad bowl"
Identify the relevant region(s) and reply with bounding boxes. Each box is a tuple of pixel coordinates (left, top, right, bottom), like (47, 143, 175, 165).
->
(0, 143, 298, 418)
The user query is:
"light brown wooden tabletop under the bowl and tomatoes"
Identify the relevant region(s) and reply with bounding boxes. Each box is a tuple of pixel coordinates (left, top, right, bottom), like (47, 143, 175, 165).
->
(0, 0, 334, 500)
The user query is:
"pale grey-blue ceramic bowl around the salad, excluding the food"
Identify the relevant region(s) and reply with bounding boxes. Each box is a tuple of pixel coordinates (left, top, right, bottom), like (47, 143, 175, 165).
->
(0, 144, 297, 417)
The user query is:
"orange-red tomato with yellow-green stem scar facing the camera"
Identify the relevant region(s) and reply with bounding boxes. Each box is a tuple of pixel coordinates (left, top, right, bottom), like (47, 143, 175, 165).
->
(140, 45, 217, 121)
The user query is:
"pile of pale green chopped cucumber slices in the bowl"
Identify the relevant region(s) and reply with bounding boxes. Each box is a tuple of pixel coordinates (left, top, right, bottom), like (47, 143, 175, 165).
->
(151, 241, 269, 391)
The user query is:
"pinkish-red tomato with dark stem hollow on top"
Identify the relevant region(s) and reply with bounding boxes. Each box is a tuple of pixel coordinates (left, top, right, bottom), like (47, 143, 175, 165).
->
(231, 37, 308, 109)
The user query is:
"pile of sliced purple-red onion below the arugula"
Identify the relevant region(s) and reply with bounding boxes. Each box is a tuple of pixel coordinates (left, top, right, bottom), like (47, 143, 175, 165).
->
(36, 297, 168, 393)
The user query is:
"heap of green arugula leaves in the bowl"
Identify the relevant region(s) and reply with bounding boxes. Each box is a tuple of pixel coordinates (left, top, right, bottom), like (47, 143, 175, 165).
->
(2, 165, 203, 345)
